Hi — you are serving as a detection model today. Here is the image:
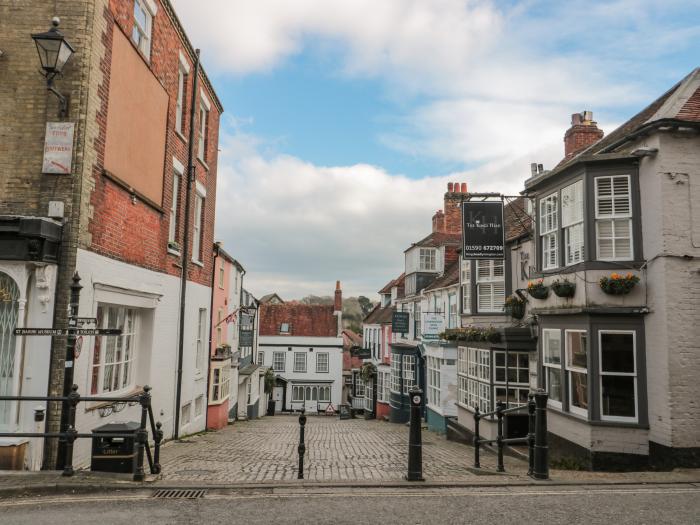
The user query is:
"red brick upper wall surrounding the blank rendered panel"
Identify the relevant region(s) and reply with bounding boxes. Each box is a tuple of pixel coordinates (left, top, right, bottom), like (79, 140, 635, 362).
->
(88, 0, 220, 286)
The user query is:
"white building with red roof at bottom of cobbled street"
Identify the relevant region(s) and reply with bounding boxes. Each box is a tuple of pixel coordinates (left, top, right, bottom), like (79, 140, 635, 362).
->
(258, 281, 343, 412)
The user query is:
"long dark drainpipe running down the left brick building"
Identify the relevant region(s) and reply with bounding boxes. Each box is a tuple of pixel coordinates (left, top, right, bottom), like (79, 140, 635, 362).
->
(173, 49, 201, 439)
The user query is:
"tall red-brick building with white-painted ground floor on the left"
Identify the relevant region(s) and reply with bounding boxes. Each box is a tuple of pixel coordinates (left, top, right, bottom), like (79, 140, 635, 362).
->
(0, 0, 223, 468)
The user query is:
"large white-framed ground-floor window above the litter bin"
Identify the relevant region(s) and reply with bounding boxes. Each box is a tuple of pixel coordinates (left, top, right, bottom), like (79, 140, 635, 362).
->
(90, 304, 139, 394)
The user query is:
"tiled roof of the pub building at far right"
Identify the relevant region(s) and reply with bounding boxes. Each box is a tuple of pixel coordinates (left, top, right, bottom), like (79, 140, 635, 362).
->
(525, 67, 700, 188)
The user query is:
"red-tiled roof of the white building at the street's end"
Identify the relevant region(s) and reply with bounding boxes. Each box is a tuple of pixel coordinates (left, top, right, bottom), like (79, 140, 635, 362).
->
(259, 301, 338, 337)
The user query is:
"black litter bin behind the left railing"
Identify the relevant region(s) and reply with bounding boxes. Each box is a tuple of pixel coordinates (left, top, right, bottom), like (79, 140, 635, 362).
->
(90, 421, 139, 473)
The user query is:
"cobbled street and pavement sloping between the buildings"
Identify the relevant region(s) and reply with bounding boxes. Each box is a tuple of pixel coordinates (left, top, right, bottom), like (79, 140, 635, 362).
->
(0, 416, 700, 498)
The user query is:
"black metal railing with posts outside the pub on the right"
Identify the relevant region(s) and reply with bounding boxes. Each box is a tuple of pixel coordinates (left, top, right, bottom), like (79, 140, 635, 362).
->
(474, 391, 549, 479)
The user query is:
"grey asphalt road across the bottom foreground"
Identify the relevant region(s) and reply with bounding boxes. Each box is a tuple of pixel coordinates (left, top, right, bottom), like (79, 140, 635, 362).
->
(0, 484, 700, 525)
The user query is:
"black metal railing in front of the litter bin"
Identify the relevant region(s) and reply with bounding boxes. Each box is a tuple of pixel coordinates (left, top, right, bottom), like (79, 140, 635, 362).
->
(0, 385, 163, 481)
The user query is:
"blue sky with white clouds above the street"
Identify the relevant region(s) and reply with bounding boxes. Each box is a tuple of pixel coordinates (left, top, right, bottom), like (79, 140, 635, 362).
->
(172, 0, 700, 300)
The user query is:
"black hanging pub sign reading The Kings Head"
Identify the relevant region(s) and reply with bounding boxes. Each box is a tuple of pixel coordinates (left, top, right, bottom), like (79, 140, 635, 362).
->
(462, 201, 505, 259)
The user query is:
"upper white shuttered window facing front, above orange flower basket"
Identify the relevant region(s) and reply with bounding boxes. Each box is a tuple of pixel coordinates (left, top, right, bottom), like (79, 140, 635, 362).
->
(595, 175, 633, 261)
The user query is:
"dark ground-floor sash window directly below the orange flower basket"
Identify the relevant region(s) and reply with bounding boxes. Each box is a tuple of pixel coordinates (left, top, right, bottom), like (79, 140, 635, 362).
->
(598, 330, 638, 422)
